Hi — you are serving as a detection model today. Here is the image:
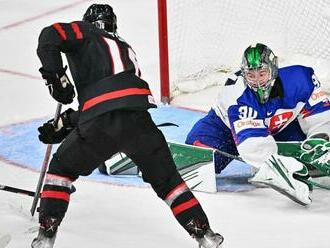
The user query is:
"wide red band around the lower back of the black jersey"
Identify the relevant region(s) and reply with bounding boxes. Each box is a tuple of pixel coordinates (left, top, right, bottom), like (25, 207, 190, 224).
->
(82, 88, 151, 111)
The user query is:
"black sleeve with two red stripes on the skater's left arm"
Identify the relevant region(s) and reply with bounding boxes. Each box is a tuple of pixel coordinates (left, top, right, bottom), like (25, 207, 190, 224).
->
(37, 22, 87, 72)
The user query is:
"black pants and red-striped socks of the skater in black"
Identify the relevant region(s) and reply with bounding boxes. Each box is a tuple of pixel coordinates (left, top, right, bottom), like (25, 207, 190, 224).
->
(39, 110, 208, 234)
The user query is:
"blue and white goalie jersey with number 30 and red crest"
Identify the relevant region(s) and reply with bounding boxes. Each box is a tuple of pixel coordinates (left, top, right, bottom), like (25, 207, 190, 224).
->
(213, 65, 330, 167)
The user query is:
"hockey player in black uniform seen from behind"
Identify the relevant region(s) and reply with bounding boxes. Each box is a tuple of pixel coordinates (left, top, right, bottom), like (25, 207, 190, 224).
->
(32, 4, 223, 248)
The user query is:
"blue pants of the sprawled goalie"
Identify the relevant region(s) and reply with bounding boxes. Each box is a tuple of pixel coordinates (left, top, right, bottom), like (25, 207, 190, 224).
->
(186, 109, 306, 173)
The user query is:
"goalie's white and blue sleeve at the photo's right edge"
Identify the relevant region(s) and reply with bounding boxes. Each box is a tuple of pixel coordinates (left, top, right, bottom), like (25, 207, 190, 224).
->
(298, 75, 330, 137)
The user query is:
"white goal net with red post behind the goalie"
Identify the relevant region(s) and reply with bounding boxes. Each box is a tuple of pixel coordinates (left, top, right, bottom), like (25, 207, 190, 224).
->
(158, 0, 330, 102)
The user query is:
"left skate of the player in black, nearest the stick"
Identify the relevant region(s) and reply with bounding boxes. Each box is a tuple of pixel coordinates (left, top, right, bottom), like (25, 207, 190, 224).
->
(31, 217, 60, 248)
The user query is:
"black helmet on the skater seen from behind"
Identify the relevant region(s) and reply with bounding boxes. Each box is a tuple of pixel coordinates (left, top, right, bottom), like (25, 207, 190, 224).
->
(83, 4, 117, 33)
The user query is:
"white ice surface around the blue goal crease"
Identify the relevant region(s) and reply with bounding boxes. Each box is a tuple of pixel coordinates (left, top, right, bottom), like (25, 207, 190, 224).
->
(0, 0, 330, 248)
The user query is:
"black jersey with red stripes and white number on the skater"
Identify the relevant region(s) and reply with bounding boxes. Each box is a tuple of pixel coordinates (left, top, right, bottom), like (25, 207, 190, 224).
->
(37, 21, 156, 122)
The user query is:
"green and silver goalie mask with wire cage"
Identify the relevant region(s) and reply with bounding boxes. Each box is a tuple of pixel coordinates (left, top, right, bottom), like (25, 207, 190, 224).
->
(241, 43, 278, 104)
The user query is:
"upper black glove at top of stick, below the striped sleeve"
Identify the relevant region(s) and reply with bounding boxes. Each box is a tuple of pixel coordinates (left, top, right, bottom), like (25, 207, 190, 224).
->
(39, 67, 75, 104)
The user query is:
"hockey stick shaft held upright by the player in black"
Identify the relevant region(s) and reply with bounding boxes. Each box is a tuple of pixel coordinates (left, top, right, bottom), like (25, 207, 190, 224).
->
(30, 103, 62, 216)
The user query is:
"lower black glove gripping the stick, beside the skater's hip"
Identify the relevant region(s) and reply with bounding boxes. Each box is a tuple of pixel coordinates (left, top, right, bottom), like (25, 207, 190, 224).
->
(38, 108, 74, 144)
